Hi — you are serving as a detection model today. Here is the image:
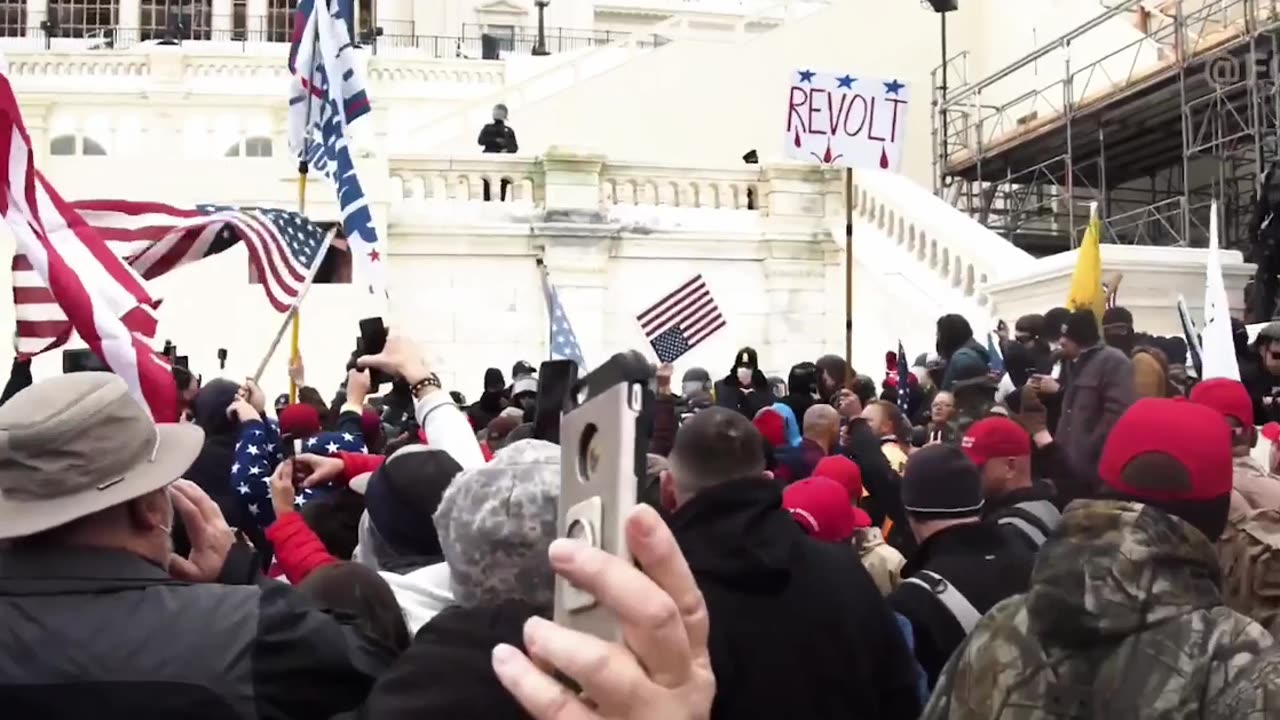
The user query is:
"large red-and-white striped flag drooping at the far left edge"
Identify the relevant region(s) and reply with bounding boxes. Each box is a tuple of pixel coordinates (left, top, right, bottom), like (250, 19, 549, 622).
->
(0, 74, 178, 423)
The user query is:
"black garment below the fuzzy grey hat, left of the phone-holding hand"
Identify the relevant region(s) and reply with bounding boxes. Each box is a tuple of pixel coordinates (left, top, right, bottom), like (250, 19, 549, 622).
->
(362, 601, 548, 720)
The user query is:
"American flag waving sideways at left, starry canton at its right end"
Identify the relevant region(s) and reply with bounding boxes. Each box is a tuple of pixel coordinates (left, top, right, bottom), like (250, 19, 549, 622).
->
(13, 200, 325, 356)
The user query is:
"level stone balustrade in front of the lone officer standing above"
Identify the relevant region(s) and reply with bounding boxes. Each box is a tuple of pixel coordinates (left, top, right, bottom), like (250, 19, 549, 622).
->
(388, 147, 793, 215)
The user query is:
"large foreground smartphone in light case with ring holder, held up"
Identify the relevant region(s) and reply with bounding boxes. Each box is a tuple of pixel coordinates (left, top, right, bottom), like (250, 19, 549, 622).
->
(554, 351, 653, 642)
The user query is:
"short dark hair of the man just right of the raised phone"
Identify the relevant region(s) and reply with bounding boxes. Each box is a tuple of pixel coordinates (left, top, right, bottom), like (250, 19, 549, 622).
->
(671, 407, 764, 492)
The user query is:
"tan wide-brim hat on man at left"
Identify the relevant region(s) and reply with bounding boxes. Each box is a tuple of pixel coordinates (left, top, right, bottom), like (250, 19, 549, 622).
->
(0, 373, 205, 539)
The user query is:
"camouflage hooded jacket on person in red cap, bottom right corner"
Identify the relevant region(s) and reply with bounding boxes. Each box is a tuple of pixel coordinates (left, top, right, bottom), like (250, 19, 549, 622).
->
(922, 500, 1280, 720)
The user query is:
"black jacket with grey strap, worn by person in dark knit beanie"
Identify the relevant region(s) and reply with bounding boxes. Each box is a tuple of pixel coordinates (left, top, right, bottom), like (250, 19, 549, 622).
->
(888, 523, 1036, 688)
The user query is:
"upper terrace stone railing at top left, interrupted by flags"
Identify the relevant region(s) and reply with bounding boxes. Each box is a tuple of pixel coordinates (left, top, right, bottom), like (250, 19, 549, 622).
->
(6, 45, 506, 97)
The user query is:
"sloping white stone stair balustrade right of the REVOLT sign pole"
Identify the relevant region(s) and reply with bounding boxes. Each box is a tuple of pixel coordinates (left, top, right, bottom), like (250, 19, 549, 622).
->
(854, 166, 1036, 310)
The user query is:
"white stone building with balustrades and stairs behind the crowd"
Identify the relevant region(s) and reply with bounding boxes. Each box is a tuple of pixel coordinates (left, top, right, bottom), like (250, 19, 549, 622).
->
(0, 0, 1249, 393)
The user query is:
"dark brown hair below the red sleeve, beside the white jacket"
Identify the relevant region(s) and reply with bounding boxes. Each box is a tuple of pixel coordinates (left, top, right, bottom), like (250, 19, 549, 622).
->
(298, 562, 412, 655)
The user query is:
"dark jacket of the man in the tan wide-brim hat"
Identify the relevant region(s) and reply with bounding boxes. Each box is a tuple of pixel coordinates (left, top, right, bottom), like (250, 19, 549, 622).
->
(0, 550, 393, 720)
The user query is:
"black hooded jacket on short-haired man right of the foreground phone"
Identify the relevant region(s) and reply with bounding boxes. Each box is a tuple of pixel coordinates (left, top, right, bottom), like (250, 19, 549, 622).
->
(671, 478, 920, 720)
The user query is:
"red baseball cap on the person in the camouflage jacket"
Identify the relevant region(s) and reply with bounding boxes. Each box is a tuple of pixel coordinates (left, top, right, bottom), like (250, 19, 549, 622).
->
(1098, 397, 1231, 501)
